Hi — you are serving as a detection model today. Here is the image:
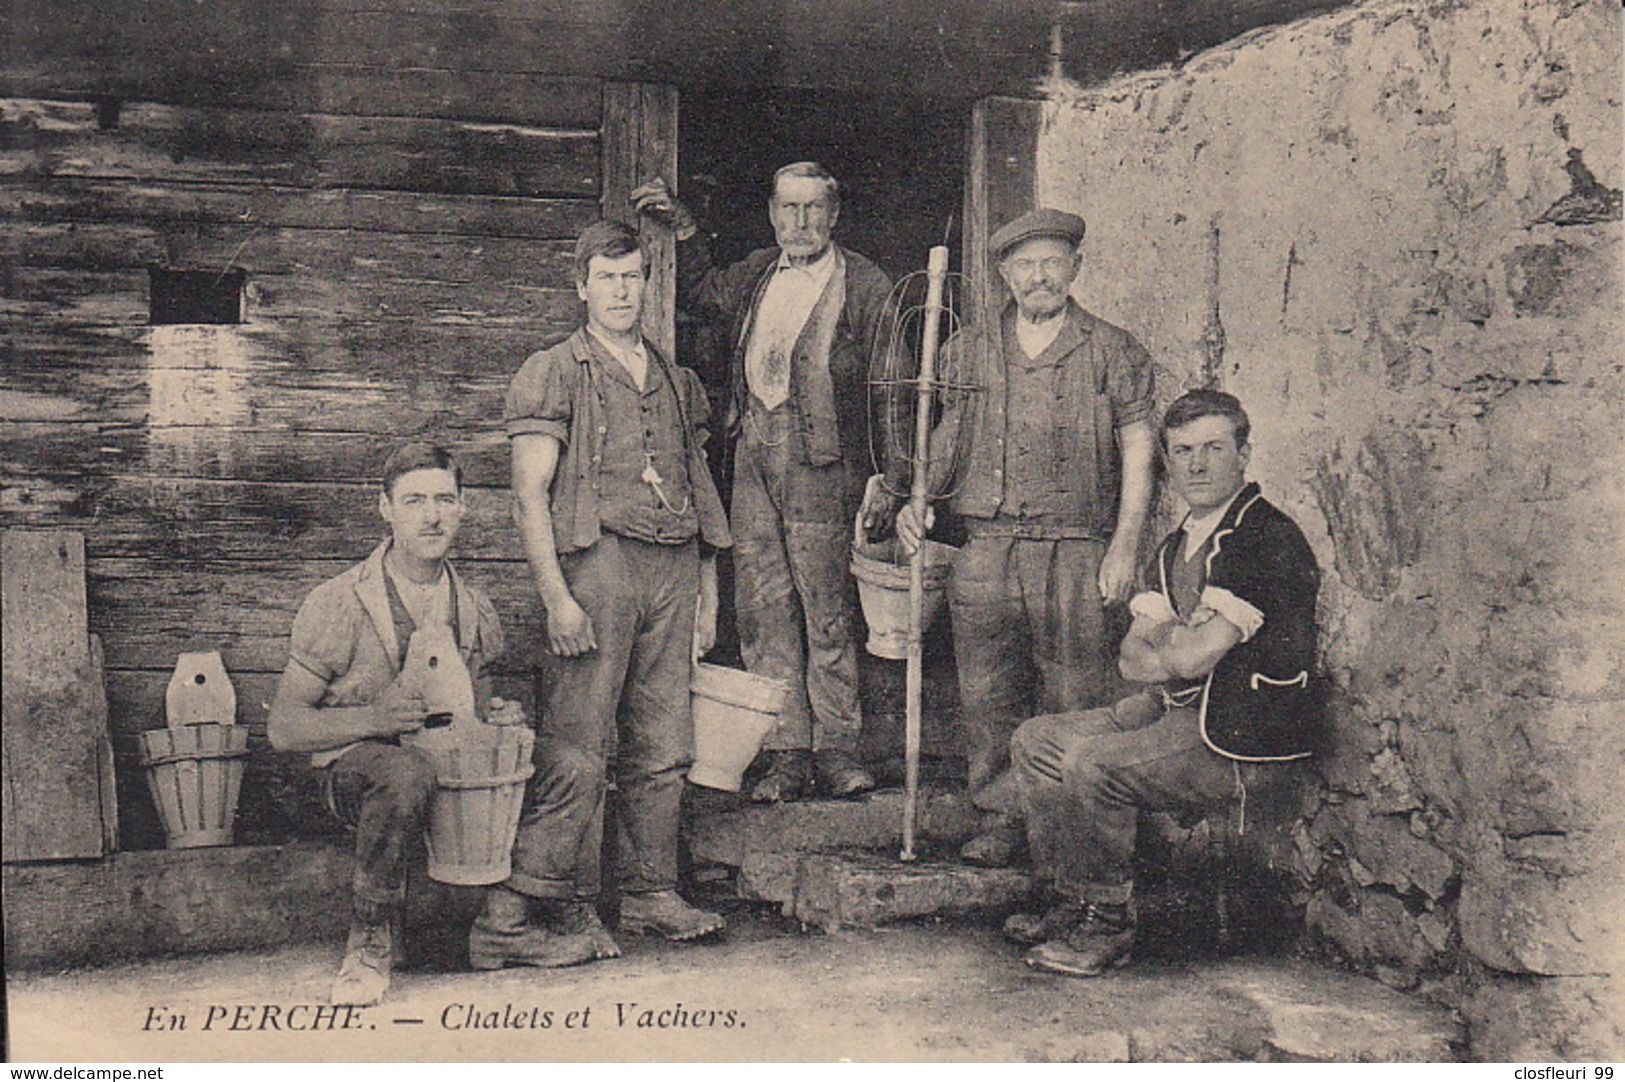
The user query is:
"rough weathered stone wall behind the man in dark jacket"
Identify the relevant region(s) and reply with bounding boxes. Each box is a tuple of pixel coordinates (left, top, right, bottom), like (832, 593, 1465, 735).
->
(1038, 0, 1625, 1059)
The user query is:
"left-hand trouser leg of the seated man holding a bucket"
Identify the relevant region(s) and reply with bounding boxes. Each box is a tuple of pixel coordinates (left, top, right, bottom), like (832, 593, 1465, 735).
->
(327, 741, 434, 921)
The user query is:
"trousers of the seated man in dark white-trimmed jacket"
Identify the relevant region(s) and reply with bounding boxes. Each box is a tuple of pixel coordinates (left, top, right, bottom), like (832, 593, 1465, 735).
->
(1012, 692, 1298, 903)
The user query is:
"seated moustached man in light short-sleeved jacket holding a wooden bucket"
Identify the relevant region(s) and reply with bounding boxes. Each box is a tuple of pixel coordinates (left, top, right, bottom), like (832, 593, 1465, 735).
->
(268, 444, 593, 1006)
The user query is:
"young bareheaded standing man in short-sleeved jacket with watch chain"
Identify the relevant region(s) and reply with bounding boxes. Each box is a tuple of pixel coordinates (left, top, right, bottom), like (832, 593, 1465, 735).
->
(505, 221, 731, 957)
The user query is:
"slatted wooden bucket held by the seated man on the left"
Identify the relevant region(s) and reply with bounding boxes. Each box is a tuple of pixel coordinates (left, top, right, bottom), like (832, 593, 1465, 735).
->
(413, 723, 536, 887)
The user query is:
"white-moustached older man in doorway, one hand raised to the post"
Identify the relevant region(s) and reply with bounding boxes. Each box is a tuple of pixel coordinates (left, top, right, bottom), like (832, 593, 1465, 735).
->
(632, 161, 895, 801)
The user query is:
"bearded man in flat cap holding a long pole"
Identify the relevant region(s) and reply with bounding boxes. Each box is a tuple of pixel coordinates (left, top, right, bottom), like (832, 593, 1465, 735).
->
(897, 208, 1154, 866)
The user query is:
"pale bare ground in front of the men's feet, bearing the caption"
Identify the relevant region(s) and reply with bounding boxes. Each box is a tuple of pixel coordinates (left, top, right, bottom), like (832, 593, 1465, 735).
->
(7, 902, 1461, 1063)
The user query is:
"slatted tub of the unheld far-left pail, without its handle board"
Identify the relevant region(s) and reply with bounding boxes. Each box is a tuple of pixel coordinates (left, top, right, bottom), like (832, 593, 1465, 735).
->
(141, 721, 249, 850)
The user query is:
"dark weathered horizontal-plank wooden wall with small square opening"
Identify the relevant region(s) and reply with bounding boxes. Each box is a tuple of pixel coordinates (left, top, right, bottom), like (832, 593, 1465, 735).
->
(0, 0, 676, 848)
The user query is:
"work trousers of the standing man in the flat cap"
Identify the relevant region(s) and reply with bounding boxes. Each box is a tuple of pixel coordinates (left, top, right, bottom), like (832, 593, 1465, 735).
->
(947, 522, 1115, 816)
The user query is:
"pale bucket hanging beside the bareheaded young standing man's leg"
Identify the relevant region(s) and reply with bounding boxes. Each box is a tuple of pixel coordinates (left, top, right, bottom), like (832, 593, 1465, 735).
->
(689, 661, 790, 793)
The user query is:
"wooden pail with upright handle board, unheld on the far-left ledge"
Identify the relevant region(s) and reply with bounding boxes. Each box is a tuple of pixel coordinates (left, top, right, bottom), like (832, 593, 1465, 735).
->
(141, 650, 249, 850)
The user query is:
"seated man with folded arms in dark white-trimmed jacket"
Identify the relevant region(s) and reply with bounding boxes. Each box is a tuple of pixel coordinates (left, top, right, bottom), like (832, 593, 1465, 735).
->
(1004, 390, 1320, 976)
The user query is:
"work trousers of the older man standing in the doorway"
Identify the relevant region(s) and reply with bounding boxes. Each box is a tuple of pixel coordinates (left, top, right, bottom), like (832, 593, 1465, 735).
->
(730, 403, 863, 752)
